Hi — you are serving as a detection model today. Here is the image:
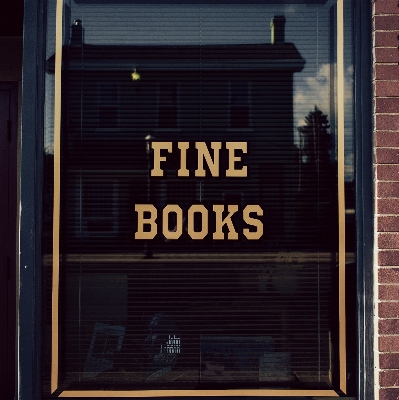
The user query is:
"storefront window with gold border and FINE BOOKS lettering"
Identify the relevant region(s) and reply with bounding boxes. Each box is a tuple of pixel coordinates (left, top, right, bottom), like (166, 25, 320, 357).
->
(42, 0, 356, 397)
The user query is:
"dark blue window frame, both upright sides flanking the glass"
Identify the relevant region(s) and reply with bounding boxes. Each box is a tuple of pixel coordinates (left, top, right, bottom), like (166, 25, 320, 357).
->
(17, 0, 374, 400)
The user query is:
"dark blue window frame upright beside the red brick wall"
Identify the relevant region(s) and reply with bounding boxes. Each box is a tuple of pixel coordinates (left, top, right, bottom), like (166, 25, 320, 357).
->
(353, 0, 377, 400)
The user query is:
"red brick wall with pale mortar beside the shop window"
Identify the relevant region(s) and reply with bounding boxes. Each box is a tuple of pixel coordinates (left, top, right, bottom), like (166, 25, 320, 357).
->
(376, 0, 399, 400)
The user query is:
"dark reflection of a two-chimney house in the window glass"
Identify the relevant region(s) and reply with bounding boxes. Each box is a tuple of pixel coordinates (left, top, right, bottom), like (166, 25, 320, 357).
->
(49, 17, 304, 253)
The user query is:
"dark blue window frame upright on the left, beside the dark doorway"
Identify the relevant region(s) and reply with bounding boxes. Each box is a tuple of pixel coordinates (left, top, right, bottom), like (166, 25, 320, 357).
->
(16, 0, 46, 399)
